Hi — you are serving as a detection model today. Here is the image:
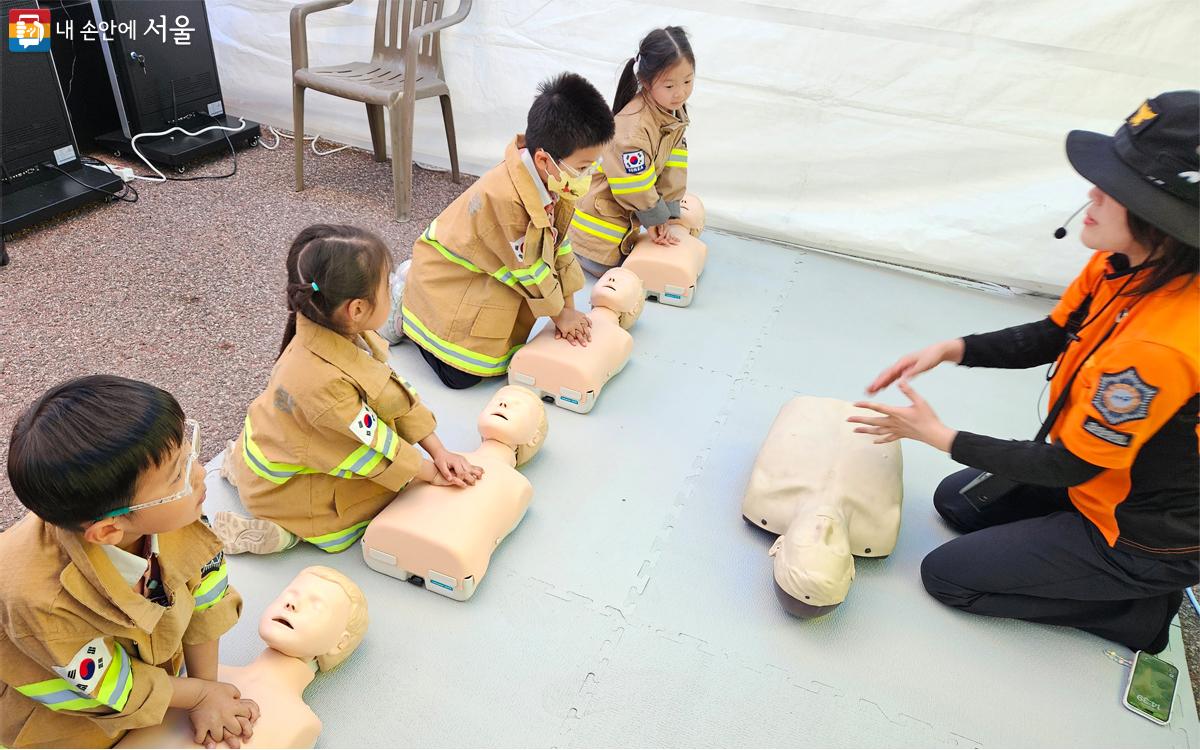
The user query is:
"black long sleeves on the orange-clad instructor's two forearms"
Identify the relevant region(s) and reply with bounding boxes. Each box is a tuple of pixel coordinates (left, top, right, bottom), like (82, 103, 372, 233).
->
(950, 318, 1103, 487)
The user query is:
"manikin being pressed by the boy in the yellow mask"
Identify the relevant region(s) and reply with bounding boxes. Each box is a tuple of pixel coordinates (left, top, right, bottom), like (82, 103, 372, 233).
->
(509, 266, 646, 414)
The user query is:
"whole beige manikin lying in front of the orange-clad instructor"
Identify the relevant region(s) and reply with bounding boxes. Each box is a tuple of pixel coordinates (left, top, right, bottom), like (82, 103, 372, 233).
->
(742, 396, 904, 618)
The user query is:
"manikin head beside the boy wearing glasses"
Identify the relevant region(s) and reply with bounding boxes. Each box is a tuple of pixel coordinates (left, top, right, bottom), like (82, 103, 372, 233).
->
(258, 565, 368, 672)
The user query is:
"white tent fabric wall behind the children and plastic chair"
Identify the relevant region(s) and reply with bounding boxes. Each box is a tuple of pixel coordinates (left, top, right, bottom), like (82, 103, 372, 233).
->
(208, 0, 1200, 293)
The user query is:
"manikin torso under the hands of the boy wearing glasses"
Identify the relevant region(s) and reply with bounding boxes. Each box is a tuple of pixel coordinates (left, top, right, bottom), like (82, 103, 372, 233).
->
(116, 648, 322, 748)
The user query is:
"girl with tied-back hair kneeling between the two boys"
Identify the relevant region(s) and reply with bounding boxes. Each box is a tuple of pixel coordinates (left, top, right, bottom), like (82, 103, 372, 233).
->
(214, 224, 484, 554)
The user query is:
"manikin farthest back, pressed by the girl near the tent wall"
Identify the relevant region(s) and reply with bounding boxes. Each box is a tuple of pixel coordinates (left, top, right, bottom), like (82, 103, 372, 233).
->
(622, 193, 708, 307)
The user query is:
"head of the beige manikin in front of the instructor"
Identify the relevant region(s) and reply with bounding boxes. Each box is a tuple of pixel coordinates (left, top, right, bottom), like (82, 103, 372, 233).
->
(770, 505, 854, 618)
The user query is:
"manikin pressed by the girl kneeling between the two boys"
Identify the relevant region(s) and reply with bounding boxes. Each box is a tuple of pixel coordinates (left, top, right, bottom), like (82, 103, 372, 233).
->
(362, 385, 548, 601)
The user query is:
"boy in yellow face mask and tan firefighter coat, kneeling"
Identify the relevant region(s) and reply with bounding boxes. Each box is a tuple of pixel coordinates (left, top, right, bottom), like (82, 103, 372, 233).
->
(392, 73, 613, 389)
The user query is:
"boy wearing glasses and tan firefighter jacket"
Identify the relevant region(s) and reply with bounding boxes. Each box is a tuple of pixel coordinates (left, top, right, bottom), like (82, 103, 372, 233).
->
(0, 376, 258, 748)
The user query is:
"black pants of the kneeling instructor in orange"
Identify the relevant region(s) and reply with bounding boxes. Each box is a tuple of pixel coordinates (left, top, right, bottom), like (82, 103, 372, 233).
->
(920, 469, 1200, 654)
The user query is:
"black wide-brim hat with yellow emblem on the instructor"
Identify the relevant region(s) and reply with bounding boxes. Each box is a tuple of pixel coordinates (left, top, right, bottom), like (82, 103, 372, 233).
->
(1067, 91, 1200, 247)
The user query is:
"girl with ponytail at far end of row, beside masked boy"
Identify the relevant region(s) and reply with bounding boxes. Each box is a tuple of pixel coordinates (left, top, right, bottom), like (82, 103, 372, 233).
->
(570, 26, 696, 277)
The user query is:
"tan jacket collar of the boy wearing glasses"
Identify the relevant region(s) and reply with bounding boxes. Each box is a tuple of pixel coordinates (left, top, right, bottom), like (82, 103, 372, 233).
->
(56, 521, 221, 632)
